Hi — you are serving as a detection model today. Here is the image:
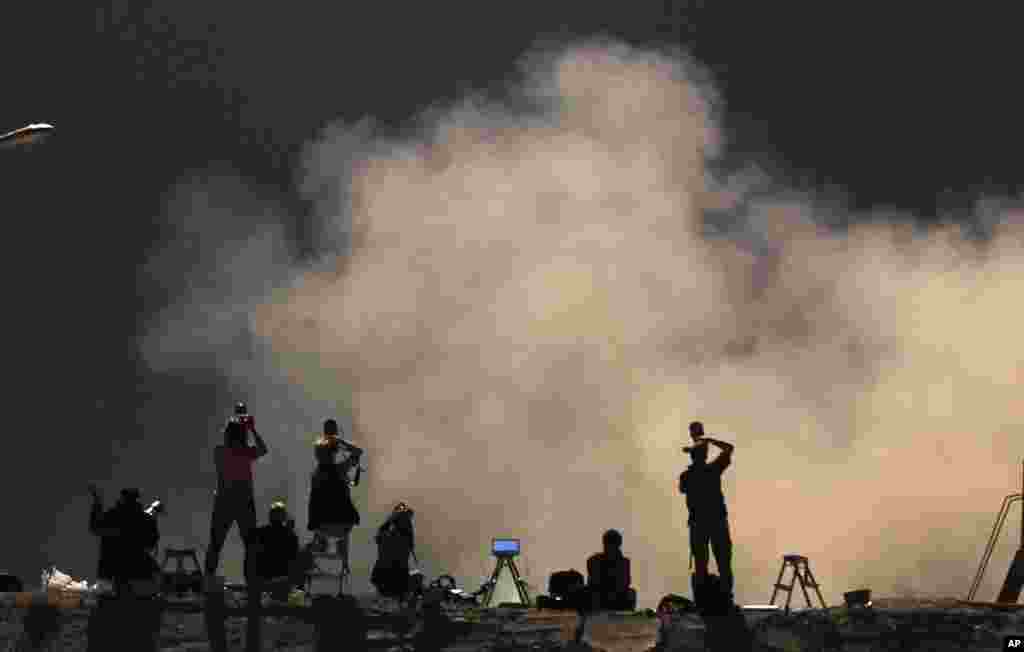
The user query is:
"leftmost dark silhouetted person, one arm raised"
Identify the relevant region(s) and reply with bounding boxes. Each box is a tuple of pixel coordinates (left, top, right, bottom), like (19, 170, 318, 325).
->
(89, 485, 160, 594)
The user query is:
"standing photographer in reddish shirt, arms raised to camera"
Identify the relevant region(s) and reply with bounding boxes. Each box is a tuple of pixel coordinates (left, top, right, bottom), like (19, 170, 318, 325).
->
(206, 403, 268, 578)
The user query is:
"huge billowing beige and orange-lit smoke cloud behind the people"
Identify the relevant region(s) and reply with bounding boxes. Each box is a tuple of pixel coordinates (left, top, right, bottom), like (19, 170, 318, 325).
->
(145, 43, 1024, 604)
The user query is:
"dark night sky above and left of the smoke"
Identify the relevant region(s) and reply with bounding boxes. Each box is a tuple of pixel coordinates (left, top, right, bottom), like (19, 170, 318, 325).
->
(0, 0, 1024, 577)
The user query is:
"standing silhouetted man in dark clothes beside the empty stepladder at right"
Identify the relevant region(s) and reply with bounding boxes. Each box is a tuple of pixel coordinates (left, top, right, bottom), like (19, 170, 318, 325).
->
(679, 421, 733, 603)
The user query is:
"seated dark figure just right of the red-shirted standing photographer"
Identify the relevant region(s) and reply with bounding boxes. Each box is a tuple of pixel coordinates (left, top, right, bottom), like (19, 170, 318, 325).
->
(246, 503, 302, 598)
